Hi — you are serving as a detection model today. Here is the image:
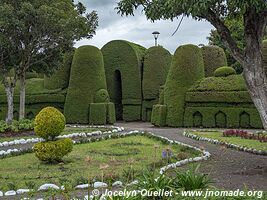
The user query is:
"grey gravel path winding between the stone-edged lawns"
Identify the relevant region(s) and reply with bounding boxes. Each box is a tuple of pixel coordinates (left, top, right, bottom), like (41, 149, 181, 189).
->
(116, 122, 267, 191)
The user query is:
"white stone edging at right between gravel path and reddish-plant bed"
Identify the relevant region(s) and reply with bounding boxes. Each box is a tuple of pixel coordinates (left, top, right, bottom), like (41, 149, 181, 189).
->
(183, 131, 267, 156)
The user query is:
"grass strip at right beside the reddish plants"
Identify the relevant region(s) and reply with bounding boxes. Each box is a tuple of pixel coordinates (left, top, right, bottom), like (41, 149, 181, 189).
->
(193, 132, 267, 151)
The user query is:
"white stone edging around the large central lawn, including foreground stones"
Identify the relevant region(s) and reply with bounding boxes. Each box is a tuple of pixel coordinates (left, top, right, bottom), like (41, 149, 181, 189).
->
(0, 130, 211, 197)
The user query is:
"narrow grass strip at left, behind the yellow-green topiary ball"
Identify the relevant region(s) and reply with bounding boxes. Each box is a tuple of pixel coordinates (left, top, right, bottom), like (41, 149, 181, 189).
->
(0, 127, 111, 142)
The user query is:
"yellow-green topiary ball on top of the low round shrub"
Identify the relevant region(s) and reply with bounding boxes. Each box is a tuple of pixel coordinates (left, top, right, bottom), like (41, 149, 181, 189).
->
(34, 107, 66, 140)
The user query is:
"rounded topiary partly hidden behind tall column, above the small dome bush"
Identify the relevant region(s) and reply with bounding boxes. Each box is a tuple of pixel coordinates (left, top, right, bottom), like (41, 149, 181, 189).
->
(201, 46, 227, 77)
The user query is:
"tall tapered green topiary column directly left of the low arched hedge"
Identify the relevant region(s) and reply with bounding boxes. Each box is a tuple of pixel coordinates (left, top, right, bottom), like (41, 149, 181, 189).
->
(164, 45, 204, 127)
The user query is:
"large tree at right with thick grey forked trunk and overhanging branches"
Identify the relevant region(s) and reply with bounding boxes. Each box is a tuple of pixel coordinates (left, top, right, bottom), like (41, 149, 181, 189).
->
(117, 0, 267, 129)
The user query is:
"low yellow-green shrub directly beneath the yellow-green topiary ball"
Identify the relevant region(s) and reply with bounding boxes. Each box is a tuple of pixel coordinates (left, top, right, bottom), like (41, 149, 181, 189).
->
(33, 138, 73, 163)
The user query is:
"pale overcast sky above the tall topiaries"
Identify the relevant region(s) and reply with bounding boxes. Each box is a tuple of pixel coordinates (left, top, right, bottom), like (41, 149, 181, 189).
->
(75, 0, 216, 53)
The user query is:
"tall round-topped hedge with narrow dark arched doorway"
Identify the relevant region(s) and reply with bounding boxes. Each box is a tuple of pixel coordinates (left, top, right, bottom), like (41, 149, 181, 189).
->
(101, 40, 145, 121)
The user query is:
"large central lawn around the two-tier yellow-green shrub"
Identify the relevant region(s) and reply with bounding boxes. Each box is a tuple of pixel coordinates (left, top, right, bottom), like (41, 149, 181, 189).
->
(0, 136, 199, 191)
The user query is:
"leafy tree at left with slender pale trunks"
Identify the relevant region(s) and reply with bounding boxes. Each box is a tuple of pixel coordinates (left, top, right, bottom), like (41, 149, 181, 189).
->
(0, 0, 98, 122)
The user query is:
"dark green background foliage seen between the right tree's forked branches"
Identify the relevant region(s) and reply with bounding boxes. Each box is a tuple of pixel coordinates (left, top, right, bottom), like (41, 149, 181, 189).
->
(207, 15, 267, 74)
